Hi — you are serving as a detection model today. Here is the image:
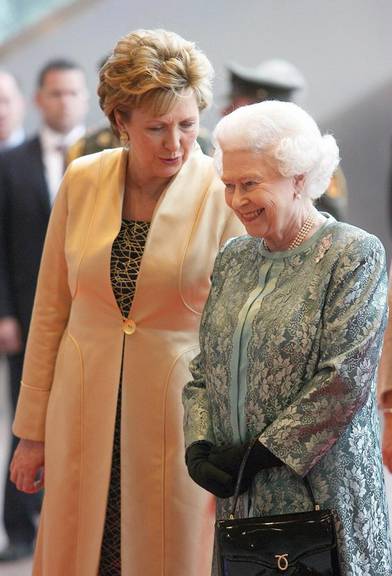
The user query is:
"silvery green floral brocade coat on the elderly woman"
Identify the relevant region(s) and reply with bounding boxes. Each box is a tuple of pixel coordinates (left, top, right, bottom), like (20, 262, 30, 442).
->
(183, 216, 392, 576)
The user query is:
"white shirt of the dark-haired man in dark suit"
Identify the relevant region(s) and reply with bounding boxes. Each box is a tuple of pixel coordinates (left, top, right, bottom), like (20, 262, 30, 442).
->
(40, 125, 86, 204)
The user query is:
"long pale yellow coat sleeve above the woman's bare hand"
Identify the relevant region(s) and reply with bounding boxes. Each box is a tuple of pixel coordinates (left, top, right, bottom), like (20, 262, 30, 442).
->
(13, 169, 71, 441)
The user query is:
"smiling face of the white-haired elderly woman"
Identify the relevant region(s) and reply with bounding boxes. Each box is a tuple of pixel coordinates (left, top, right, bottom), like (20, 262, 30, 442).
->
(221, 150, 303, 244)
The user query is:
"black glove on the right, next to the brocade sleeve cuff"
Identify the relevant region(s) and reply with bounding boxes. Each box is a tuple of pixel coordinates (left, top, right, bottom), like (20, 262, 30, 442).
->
(208, 440, 284, 494)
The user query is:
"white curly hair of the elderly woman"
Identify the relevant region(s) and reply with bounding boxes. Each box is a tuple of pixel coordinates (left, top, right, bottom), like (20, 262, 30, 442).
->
(213, 100, 340, 200)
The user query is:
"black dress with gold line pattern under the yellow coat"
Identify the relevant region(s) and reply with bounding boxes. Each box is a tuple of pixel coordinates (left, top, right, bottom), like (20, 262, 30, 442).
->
(99, 220, 150, 576)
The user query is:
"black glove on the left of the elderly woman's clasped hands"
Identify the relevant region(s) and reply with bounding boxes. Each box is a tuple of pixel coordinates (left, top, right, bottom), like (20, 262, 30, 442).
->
(185, 440, 235, 498)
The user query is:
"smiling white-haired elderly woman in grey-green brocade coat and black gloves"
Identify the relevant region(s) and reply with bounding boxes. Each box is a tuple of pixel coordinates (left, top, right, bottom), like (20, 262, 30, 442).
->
(183, 101, 392, 576)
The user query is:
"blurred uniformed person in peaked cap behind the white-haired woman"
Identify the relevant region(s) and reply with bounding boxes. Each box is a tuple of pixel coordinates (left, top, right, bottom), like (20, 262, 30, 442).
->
(222, 59, 347, 220)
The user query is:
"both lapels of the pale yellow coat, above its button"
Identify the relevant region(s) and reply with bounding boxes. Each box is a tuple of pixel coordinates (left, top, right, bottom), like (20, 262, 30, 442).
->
(89, 145, 213, 320)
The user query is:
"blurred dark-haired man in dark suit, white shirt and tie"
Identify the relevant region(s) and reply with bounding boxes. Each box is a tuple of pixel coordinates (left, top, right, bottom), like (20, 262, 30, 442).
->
(0, 60, 88, 562)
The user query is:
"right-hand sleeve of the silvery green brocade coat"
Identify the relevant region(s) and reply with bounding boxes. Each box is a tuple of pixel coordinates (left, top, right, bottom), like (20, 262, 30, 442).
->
(260, 235, 386, 476)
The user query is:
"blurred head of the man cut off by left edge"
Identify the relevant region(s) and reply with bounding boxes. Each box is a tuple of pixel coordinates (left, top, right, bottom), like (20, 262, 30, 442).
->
(0, 70, 25, 151)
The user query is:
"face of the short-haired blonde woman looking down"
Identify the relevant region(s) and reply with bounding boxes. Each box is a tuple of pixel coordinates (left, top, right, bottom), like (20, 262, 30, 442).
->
(116, 92, 199, 179)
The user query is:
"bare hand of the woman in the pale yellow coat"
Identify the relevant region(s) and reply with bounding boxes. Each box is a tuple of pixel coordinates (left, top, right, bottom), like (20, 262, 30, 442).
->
(10, 438, 45, 494)
